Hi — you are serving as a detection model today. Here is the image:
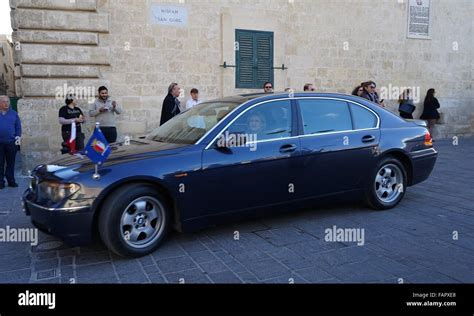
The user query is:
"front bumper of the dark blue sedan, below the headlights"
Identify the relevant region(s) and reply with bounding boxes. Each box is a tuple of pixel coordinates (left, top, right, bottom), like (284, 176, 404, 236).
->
(23, 190, 94, 246)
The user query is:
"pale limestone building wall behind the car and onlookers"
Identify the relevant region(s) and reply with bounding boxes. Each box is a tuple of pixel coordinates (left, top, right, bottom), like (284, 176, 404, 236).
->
(10, 0, 474, 168)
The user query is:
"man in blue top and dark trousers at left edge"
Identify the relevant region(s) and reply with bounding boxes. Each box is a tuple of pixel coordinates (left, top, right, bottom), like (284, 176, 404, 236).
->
(0, 95, 21, 190)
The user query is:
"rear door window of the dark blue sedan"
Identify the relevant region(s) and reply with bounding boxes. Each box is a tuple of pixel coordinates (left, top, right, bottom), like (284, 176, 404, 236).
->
(298, 99, 352, 135)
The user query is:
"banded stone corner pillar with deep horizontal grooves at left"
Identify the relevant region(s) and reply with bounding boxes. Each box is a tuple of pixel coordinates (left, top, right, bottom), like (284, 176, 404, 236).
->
(10, 0, 110, 172)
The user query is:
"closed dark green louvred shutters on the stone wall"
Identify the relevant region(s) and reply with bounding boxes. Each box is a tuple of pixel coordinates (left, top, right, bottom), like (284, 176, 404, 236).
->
(235, 30, 273, 89)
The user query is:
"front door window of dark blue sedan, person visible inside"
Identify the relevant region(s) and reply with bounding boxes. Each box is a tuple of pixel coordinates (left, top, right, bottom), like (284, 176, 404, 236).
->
(227, 100, 292, 141)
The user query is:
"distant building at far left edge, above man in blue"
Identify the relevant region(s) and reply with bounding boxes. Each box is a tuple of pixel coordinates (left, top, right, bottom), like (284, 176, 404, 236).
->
(0, 35, 15, 97)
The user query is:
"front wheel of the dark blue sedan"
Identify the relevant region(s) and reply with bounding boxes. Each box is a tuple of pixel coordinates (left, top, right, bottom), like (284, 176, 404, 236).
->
(98, 184, 170, 257)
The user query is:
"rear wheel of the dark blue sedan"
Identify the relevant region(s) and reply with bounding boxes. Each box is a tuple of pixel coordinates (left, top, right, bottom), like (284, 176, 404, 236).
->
(366, 157, 407, 210)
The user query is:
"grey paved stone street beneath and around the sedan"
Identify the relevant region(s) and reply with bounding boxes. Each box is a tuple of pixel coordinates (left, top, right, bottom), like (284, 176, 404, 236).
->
(0, 139, 474, 283)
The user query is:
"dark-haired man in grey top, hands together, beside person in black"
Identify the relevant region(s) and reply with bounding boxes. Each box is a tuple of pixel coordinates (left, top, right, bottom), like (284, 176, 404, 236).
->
(89, 86, 122, 144)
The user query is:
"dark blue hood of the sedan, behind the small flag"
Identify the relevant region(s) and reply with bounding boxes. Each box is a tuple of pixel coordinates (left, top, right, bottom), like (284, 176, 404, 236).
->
(36, 141, 191, 173)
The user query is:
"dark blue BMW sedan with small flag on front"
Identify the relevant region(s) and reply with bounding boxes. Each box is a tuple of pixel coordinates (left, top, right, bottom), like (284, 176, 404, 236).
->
(23, 93, 437, 257)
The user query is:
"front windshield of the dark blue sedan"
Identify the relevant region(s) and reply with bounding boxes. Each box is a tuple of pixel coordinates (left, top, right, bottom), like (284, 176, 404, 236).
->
(147, 102, 240, 144)
